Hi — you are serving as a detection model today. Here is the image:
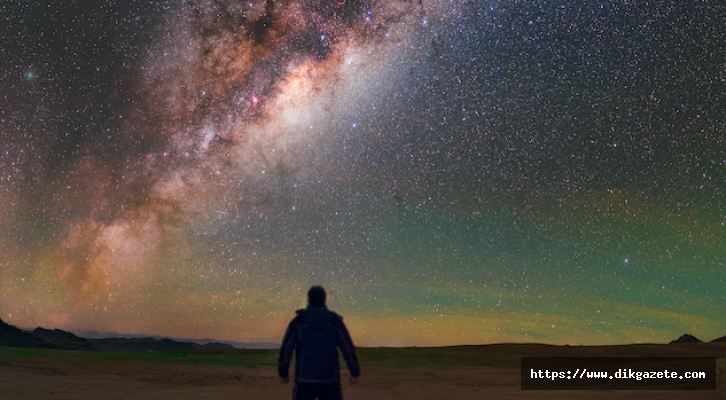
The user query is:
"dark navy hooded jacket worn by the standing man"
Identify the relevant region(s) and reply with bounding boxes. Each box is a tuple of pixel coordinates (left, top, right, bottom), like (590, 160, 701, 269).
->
(277, 306, 360, 383)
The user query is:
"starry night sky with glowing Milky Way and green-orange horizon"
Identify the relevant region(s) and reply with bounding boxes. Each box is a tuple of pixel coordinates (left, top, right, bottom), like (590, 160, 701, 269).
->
(0, 0, 726, 346)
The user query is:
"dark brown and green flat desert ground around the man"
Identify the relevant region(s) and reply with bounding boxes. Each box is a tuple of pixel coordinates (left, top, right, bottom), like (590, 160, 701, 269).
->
(0, 343, 726, 400)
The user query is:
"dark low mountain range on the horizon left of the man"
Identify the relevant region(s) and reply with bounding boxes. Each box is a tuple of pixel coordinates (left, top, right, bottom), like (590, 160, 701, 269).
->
(0, 319, 279, 352)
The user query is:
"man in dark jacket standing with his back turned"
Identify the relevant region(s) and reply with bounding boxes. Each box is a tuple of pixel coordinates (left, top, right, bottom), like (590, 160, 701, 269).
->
(277, 286, 360, 400)
